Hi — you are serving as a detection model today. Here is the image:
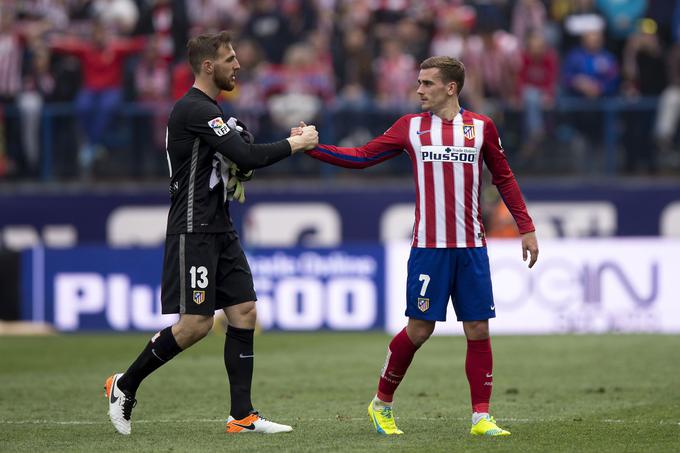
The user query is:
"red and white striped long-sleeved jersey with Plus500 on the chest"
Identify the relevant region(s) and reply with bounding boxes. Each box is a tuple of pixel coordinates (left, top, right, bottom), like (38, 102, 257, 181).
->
(308, 109, 534, 248)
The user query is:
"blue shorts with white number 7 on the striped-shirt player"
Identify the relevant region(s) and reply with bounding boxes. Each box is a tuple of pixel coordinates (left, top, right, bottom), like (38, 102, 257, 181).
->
(406, 247, 496, 321)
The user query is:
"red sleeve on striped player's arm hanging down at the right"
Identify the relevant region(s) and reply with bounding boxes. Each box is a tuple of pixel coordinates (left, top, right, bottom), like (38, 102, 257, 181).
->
(482, 121, 535, 234)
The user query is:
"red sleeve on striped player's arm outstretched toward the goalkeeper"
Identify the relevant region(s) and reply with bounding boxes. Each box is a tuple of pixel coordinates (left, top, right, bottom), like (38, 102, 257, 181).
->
(307, 116, 408, 168)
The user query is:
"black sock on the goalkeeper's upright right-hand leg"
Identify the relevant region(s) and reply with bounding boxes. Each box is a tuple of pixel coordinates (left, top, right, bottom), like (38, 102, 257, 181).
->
(224, 326, 255, 420)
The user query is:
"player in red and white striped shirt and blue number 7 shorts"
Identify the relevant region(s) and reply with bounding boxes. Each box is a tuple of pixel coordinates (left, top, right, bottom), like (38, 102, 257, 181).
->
(300, 57, 538, 436)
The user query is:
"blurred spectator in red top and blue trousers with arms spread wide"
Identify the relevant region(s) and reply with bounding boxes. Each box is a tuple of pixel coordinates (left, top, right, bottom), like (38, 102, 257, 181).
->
(52, 22, 144, 174)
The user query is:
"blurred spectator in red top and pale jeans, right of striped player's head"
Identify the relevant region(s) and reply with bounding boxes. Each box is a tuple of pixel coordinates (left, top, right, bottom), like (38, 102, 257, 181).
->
(517, 30, 559, 160)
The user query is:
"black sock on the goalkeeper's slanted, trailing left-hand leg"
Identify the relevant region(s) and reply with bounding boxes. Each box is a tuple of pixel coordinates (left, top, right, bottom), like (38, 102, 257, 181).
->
(118, 326, 182, 395)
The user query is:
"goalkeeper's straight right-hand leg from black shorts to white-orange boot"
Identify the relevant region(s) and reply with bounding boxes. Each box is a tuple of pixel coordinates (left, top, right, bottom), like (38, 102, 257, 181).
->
(216, 234, 293, 434)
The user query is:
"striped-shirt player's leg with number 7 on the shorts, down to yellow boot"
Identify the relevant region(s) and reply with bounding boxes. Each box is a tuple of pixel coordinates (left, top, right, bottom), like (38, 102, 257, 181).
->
(368, 248, 450, 435)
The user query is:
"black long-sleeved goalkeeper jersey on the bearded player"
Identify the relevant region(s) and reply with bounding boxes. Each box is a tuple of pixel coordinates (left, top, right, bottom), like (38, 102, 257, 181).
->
(167, 88, 290, 234)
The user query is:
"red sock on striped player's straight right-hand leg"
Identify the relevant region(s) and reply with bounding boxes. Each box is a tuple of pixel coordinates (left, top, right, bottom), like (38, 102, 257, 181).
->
(465, 338, 493, 412)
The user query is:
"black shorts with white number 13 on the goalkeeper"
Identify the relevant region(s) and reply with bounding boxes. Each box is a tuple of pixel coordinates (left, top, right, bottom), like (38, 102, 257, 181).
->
(161, 233, 256, 316)
